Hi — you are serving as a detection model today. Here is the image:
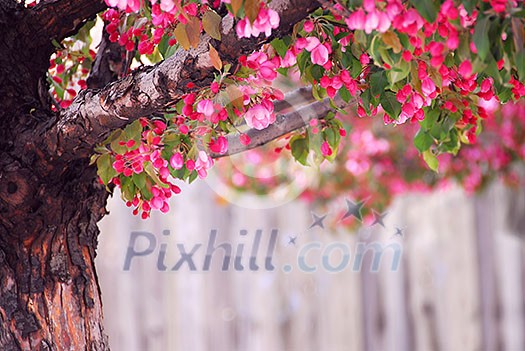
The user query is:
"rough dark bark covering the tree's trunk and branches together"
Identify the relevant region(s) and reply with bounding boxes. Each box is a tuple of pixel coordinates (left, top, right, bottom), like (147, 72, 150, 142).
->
(0, 0, 328, 351)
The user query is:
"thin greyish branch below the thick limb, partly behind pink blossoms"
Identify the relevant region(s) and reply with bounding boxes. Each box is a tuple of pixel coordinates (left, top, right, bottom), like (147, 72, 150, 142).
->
(211, 95, 348, 158)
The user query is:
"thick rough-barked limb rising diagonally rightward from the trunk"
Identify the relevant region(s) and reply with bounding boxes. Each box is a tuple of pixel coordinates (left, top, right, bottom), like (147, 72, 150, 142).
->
(45, 0, 319, 159)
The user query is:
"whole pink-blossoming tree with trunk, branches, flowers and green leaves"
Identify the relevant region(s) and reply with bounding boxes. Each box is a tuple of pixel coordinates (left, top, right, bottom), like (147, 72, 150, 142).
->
(0, 0, 525, 350)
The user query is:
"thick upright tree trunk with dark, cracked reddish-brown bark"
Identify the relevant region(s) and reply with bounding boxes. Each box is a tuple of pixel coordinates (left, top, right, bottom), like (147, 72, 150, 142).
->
(0, 0, 109, 351)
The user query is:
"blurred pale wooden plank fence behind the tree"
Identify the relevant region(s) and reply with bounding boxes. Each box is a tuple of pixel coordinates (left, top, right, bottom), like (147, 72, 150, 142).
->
(97, 175, 525, 351)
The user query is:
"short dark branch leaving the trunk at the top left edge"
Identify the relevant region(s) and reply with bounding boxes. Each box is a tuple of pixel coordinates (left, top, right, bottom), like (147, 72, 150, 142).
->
(31, 0, 107, 42)
